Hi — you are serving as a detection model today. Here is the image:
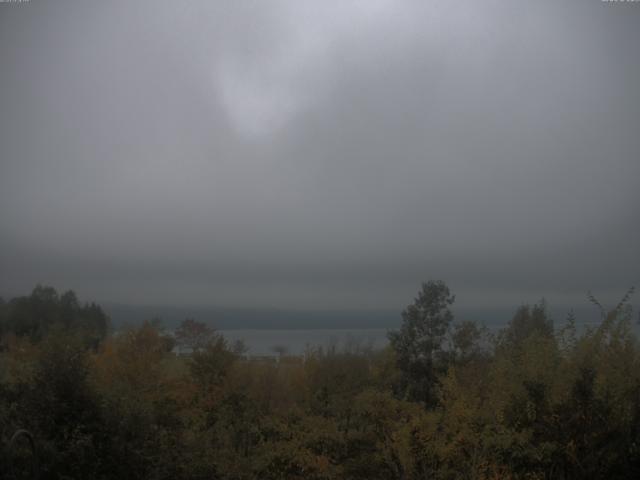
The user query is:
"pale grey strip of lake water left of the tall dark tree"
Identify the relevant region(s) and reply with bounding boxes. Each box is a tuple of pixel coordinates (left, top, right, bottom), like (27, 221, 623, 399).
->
(219, 328, 388, 356)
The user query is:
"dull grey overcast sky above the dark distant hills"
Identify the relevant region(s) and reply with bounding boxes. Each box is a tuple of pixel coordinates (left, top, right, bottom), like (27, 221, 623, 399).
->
(0, 0, 640, 308)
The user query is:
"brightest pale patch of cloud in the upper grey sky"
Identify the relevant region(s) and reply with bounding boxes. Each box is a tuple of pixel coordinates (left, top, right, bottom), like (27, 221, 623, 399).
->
(214, 0, 404, 137)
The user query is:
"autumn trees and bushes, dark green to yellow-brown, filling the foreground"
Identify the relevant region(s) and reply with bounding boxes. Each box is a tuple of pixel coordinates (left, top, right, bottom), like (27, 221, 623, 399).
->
(0, 281, 640, 480)
